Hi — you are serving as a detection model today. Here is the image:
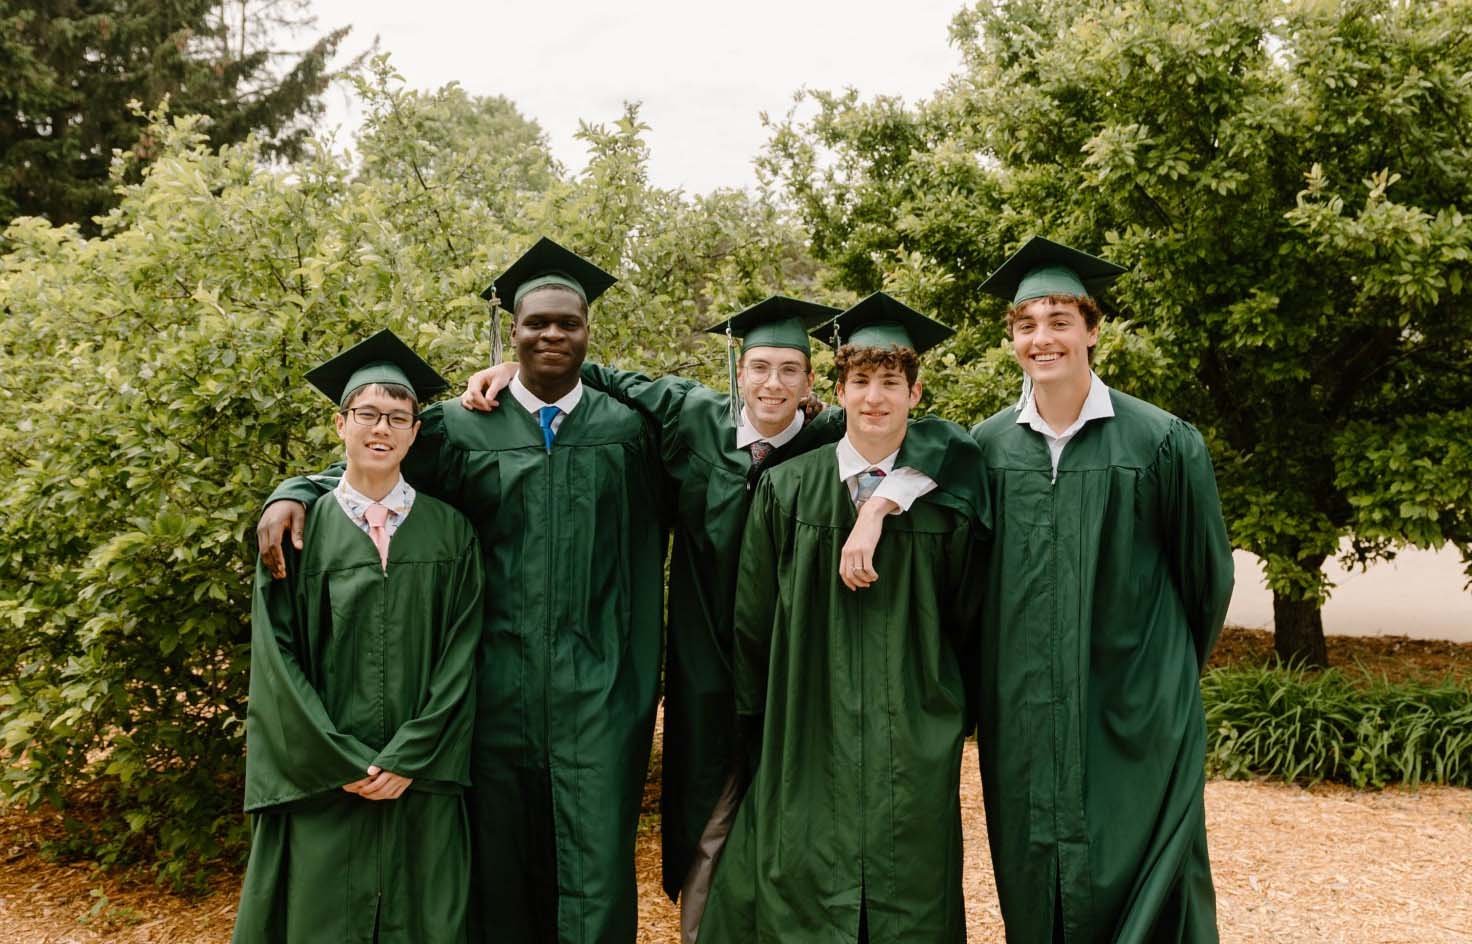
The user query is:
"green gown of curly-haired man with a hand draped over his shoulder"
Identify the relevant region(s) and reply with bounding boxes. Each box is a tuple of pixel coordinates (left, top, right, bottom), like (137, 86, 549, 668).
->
(701, 448, 976, 944)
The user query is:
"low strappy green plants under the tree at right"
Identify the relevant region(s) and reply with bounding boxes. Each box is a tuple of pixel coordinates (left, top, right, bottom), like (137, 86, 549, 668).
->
(1201, 667, 1472, 789)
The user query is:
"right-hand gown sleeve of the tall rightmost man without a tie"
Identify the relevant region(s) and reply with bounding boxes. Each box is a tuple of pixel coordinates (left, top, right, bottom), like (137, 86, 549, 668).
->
(1160, 421, 1234, 667)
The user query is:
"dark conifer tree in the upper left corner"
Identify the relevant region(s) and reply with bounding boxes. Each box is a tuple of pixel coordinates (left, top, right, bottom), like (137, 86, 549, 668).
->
(0, 0, 347, 233)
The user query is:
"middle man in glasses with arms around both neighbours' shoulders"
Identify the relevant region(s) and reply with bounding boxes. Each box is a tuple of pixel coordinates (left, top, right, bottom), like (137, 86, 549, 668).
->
(462, 295, 974, 944)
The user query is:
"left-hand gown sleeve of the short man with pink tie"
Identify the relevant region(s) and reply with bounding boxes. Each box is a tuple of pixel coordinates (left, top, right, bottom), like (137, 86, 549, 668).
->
(246, 546, 374, 813)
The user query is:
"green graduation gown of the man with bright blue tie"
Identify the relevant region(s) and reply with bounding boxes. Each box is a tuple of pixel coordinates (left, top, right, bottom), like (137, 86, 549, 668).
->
(272, 389, 665, 944)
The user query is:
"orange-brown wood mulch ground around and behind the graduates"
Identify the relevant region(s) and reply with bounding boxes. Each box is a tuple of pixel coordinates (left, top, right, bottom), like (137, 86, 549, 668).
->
(0, 630, 1472, 944)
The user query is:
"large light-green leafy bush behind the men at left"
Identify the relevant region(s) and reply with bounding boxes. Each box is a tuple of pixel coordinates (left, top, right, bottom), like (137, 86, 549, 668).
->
(0, 60, 817, 881)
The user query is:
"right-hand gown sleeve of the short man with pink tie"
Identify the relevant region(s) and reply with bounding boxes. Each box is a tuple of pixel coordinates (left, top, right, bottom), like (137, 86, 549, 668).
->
(372, 529, 486, 785)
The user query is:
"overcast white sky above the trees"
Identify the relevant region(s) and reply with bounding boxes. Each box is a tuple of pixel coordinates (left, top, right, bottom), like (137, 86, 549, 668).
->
(312, 0, 964, 193)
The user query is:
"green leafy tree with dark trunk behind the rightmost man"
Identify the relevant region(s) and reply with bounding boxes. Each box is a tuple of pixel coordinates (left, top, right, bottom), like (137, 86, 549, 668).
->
(764, 0, 1472, 664)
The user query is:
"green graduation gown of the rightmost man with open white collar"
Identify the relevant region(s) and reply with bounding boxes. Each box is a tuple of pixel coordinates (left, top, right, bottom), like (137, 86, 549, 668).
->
(971, 390, 1232, 944)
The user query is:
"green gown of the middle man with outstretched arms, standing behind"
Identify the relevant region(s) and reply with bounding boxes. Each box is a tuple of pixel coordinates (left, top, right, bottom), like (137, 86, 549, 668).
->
(583, 364, 974, 898)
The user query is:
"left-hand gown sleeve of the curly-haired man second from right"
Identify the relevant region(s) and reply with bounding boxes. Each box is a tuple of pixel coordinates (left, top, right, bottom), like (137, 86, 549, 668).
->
(732, 477, 785, 773)
